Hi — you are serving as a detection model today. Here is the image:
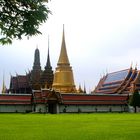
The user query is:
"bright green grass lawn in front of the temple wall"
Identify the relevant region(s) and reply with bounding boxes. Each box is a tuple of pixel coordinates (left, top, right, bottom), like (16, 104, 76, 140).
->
(0, 113, 140, 140)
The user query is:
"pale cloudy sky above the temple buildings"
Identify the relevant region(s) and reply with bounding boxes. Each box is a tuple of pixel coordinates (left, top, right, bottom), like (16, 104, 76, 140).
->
(0, 0, 140, 91)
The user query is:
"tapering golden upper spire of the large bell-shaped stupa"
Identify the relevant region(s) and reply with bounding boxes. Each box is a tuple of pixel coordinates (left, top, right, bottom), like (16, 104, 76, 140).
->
(58, 25, 70, 65)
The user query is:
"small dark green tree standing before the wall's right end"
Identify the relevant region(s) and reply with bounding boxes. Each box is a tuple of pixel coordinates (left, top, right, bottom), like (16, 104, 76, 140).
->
(130, 91, 140, 113)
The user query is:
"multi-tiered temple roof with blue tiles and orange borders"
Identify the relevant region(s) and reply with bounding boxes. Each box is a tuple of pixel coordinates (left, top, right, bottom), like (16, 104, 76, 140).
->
(93, 67, 140, 94)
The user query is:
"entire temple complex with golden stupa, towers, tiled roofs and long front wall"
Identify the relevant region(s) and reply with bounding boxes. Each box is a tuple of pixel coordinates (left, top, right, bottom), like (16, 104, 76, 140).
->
(0, 27, 140, 113)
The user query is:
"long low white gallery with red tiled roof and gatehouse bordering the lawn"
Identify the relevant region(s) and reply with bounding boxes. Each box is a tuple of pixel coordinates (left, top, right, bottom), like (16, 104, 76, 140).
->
(0, 89, 129, 114)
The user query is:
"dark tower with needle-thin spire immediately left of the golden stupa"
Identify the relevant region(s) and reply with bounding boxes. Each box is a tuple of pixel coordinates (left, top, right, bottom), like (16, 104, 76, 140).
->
(41, 38, 53, 89)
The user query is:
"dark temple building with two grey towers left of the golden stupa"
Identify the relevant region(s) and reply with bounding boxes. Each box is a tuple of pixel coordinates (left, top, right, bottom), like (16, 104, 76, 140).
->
(9, 38, 53, 94)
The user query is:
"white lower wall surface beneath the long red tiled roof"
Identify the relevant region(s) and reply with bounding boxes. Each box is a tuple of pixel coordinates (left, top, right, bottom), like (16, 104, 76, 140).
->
(0, 104, 130, 113)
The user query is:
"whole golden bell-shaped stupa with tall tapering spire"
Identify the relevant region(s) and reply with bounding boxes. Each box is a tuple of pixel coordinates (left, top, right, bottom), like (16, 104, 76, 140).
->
(53, 26, 76, 93)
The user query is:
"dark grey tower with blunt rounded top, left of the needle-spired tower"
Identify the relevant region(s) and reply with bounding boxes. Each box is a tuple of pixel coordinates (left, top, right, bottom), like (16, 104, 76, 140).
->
(30, 48, 41, 90)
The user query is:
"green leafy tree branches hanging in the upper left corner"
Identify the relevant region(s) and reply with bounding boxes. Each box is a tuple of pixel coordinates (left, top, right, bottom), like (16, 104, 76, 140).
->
(0, 0, 51, 44)
